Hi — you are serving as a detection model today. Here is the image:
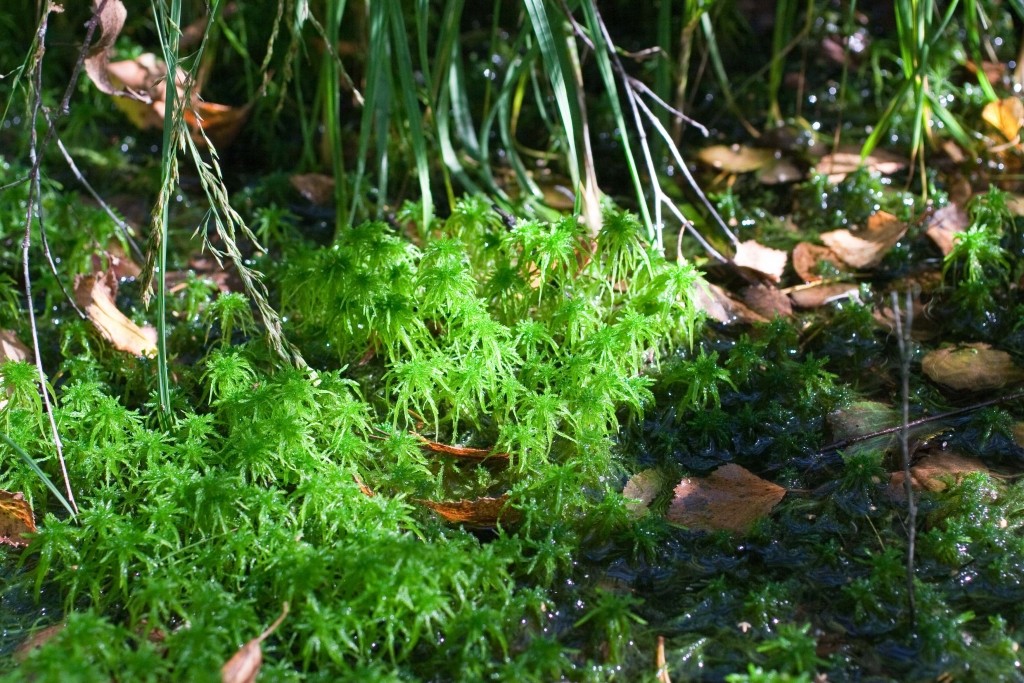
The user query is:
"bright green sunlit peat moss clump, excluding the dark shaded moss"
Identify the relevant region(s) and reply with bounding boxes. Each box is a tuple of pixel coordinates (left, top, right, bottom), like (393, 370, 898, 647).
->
(0, 201, 700, 680)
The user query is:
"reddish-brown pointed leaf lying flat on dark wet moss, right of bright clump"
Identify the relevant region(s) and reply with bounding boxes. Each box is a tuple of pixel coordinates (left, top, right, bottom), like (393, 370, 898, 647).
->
(666, 463, 785, 533)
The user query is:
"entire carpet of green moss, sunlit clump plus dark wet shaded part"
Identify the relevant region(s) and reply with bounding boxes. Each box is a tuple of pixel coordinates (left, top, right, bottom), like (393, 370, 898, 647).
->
(2, 167, 1024, 680)
